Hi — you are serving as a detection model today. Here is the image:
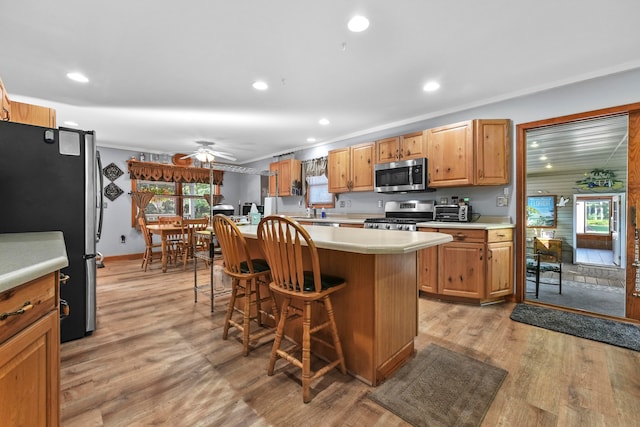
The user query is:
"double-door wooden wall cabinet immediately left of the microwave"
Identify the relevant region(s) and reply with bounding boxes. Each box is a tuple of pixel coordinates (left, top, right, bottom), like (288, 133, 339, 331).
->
(327, 142, 375, 193)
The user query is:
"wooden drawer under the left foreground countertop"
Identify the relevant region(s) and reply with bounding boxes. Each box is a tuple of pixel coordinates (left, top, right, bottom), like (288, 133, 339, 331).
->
(0, 272, 58, 343)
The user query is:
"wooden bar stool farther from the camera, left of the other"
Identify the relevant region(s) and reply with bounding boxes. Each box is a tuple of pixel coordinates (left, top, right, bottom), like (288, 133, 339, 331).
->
(213, 214, 277, 356)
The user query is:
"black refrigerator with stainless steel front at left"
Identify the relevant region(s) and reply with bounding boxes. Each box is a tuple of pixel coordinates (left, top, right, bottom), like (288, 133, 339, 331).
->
(0, 122, 103, 342)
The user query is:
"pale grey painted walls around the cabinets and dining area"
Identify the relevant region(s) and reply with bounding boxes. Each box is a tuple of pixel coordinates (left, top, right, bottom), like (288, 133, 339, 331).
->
(96, 69, 640, 256)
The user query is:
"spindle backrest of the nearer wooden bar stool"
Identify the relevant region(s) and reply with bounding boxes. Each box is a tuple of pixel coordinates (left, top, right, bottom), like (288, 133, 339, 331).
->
(257, 215, 322, 293)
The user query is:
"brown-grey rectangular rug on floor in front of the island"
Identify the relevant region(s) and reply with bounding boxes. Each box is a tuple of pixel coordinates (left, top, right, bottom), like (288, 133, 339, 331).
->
(368, 344, 507, 427)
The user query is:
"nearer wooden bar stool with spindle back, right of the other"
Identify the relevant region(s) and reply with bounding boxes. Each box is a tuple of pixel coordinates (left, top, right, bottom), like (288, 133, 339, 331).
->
(257, 216, 347, 403)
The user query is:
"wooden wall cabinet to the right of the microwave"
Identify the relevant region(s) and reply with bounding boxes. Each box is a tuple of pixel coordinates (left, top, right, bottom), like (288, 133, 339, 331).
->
(426, 119, 510, 188)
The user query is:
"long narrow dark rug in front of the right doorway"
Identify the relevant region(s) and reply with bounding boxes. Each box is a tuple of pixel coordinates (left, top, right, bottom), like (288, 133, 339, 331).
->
(511, 304, 640, 351)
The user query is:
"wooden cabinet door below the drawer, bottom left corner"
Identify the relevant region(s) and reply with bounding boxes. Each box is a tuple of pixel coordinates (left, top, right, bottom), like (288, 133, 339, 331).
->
(0, 311, 60, 426)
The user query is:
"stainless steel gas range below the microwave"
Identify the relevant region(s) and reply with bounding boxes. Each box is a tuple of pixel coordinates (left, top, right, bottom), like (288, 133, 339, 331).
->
(364, 200, 436, 231)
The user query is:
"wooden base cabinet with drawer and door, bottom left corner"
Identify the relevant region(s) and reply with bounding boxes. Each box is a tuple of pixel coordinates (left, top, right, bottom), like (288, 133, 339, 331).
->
(0, 272, 60, 426)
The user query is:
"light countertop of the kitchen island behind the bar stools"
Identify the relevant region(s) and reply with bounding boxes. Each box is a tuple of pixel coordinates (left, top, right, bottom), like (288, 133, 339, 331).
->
(234, 225, 453, 254)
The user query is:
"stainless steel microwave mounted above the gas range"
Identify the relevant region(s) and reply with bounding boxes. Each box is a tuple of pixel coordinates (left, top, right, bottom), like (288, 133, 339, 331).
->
(374, 158, 432, 193)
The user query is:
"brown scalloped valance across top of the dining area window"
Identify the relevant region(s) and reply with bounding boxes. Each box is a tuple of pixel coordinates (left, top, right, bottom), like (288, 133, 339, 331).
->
(127, 160, 224, 185)
